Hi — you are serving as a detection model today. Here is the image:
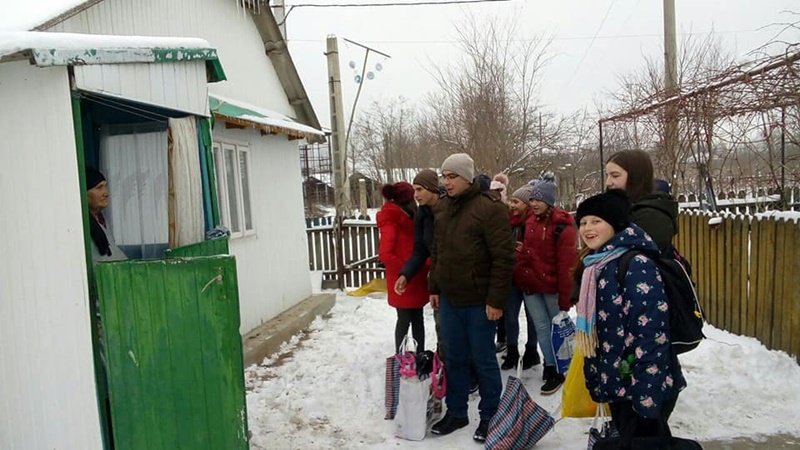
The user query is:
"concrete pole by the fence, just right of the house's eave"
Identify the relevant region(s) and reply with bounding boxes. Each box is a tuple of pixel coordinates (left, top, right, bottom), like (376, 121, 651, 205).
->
(325, 36, 350, 216)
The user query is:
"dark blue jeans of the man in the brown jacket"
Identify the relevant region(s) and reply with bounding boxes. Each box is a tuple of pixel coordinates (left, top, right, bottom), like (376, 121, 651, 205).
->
(439, 296, 503, 420)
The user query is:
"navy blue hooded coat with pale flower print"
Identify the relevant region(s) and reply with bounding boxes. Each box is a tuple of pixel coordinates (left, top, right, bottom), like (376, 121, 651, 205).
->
(583, 225, 686, 418)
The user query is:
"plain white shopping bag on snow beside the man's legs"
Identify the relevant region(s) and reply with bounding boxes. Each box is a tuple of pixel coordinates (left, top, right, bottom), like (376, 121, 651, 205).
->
(394, 377, 431, 441)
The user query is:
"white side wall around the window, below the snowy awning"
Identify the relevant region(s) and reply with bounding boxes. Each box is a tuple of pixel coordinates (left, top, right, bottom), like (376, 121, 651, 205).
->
(213, 123, 311, 334)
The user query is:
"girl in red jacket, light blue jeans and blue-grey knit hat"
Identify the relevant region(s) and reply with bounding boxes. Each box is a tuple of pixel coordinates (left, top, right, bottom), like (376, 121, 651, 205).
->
(514, 179, 578, 395)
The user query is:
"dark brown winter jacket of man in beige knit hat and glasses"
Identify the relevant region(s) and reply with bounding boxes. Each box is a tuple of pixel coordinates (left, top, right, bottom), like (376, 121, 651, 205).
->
(430, 183, 514, 309)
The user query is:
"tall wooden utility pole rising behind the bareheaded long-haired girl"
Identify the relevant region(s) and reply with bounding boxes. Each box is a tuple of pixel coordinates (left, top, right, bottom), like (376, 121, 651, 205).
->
(664, 0, 678, 181)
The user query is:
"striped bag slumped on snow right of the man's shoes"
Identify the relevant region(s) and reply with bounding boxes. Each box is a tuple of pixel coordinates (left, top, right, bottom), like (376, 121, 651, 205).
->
(485, 361, 555, 450)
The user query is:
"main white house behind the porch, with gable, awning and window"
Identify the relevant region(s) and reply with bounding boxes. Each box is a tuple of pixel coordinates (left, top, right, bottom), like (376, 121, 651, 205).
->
(36, 0, 322, 334)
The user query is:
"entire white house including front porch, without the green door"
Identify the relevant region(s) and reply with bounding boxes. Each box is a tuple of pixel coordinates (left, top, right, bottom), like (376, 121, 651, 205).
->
(0, 0, 323, 449)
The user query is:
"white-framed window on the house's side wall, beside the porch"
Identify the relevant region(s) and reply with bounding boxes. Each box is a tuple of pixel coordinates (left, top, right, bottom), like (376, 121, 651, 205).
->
(212, 141, 256, 239)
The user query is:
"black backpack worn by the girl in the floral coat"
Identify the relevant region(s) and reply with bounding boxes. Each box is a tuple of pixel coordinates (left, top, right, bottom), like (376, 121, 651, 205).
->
(617, 248, 705, 355)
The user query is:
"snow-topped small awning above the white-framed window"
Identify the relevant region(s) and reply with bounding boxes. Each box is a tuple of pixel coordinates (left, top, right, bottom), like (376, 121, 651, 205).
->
(208, 94, 325, 141)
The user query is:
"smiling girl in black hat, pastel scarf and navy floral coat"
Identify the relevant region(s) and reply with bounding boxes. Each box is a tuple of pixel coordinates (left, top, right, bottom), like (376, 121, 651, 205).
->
(575, 189, 686, 449)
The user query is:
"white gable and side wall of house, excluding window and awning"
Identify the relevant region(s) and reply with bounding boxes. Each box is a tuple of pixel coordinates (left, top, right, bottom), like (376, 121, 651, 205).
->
(50, 0, 318, 334)
